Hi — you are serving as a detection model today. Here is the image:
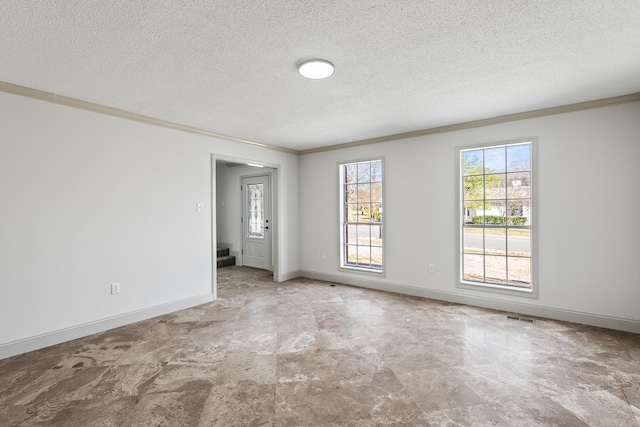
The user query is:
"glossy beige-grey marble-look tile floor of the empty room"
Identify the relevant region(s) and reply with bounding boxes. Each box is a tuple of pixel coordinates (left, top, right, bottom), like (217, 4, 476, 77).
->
(0, 267, 640, 427)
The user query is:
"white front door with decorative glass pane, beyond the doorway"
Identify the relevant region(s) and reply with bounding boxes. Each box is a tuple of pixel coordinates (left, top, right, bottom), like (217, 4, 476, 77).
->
(241, 175, 272, 270)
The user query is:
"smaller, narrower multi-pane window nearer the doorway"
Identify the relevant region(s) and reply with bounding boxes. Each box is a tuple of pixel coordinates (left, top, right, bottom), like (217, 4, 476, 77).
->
(339, 159, 384, 273)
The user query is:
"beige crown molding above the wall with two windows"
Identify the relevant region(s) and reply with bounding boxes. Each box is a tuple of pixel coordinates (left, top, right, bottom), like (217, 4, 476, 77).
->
(298, 92, 640, 154)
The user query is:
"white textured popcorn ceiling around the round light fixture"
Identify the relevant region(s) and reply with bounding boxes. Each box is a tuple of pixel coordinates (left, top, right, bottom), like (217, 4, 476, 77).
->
(0, 0, 640, 150)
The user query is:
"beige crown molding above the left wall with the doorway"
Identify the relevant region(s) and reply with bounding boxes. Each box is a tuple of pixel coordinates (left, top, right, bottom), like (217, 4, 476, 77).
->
(0, 81, 300, 154)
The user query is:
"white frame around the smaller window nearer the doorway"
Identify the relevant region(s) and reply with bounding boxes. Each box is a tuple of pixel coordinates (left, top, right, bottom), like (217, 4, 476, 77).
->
(337, 157, 387, 277)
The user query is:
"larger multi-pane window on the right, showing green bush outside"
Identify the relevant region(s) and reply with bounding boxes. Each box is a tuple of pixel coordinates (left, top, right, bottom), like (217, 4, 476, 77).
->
(459, 141, 535, 293)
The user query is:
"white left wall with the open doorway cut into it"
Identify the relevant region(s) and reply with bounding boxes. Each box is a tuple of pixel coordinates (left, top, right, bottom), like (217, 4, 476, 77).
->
(0, 93, 298, 358)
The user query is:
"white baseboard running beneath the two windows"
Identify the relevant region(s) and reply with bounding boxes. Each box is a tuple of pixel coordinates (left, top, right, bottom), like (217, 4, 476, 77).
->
(299, 270, 640, 334)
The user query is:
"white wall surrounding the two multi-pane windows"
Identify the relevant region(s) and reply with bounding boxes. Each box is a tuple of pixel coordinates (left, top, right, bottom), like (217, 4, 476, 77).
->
(300, 103, 640, 332)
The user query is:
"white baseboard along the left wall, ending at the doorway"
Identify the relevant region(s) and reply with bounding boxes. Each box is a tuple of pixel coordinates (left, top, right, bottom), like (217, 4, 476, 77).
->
(0, 292, 213, 360)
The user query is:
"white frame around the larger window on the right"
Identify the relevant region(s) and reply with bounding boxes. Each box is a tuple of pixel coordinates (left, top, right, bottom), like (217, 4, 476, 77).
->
(455, 137, 538, 298)
